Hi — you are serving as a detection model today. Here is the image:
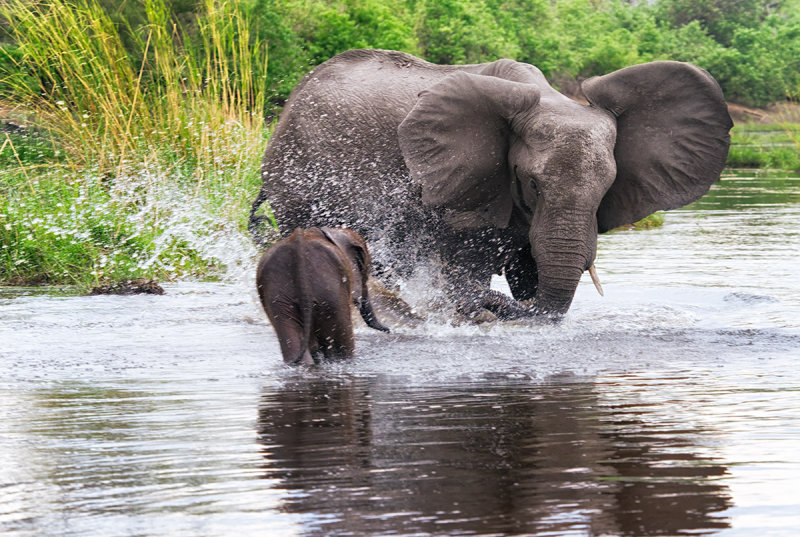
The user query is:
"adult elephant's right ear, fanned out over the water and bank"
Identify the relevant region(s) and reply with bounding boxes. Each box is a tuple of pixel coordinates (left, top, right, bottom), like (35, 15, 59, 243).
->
(581, 62, 733, 233)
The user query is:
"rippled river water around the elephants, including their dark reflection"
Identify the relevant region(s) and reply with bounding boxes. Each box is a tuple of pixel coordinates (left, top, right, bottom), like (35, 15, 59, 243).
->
(0, 174, 800, 537)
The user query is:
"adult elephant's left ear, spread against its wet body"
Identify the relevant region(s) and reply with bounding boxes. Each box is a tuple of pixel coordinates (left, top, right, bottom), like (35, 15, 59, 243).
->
(398, 72, 539, 227)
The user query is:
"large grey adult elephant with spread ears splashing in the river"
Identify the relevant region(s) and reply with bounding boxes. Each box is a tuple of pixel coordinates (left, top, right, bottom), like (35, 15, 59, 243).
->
(250, 50, 732, 318)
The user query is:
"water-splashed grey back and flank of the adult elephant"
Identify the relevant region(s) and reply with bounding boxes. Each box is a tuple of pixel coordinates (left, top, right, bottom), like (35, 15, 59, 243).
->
(262, 50, 458, 238)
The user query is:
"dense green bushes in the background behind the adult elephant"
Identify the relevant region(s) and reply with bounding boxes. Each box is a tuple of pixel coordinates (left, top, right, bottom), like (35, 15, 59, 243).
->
(247, 0, 800, 106)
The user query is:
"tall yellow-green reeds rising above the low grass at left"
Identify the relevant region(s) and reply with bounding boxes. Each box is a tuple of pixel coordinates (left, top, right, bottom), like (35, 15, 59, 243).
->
(0, 0, 267, 180)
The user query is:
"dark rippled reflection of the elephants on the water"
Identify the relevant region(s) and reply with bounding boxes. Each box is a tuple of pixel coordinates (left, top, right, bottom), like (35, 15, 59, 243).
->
(258, 379, 730, 535)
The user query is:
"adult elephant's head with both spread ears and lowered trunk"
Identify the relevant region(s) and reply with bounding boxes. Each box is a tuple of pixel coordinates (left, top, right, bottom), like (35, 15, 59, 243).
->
(398, 60, 732, 314)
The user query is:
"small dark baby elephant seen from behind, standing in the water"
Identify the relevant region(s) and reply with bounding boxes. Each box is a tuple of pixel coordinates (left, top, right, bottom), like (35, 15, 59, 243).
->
(256, 227, 389, 365)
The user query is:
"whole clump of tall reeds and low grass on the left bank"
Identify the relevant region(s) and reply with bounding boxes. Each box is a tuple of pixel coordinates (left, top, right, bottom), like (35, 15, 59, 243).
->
(0, 0, 267, 287)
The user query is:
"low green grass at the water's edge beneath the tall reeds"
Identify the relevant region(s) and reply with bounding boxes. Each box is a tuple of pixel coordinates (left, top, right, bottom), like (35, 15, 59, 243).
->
(0, 162, 258, 289)
